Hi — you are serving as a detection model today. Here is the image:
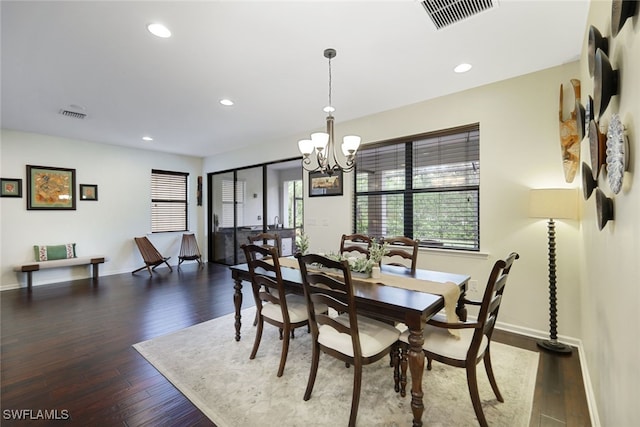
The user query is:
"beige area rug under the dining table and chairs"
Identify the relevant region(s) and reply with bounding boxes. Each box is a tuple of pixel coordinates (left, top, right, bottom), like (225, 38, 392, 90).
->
(134, 308, 538, 427)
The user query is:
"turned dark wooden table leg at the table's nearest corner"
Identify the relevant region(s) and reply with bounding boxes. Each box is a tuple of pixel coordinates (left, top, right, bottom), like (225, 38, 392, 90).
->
(406, 316, 425, 427)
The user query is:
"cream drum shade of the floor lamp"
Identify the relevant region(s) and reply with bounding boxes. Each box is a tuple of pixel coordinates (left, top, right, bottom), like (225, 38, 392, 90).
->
(529, 188, 578, 219)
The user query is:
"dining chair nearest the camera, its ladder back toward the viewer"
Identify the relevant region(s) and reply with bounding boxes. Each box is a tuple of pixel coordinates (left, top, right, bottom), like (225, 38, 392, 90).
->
(296, 253, 400, 427)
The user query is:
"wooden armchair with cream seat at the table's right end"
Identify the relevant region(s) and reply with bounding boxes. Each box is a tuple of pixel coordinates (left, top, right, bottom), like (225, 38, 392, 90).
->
(396, 252, 519, 427)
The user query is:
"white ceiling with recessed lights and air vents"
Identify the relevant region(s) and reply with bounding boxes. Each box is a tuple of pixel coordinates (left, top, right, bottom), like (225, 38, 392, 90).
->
(1, 0, 589, 157)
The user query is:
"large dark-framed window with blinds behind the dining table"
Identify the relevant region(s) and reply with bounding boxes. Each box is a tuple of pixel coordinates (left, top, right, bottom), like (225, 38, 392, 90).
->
(354, 124, 480, 251)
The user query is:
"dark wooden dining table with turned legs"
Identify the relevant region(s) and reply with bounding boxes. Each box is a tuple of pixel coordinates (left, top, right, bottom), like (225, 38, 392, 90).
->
(230, 264, 470, 427)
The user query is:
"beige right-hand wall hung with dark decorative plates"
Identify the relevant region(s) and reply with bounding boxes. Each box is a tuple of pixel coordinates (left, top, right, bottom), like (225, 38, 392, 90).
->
(579, 0, 640, 426)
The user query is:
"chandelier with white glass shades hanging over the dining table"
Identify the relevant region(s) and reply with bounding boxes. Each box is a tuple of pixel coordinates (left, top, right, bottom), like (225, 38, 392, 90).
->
(298, 49, 360, 176)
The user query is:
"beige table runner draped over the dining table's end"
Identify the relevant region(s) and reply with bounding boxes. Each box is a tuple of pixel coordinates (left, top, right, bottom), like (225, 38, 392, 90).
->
(278, 257, 460, 337)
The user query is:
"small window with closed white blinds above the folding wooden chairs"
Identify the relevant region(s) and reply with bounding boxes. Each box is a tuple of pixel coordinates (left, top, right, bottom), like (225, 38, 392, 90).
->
(151, 169, 189, 233)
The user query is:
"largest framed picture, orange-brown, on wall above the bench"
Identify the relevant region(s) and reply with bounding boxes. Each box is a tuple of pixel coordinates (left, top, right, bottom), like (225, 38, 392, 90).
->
(27, 165, 76, 210)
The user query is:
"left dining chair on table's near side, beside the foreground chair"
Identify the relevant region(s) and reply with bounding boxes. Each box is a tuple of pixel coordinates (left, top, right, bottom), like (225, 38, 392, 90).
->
(242, 244, 309, 377)
